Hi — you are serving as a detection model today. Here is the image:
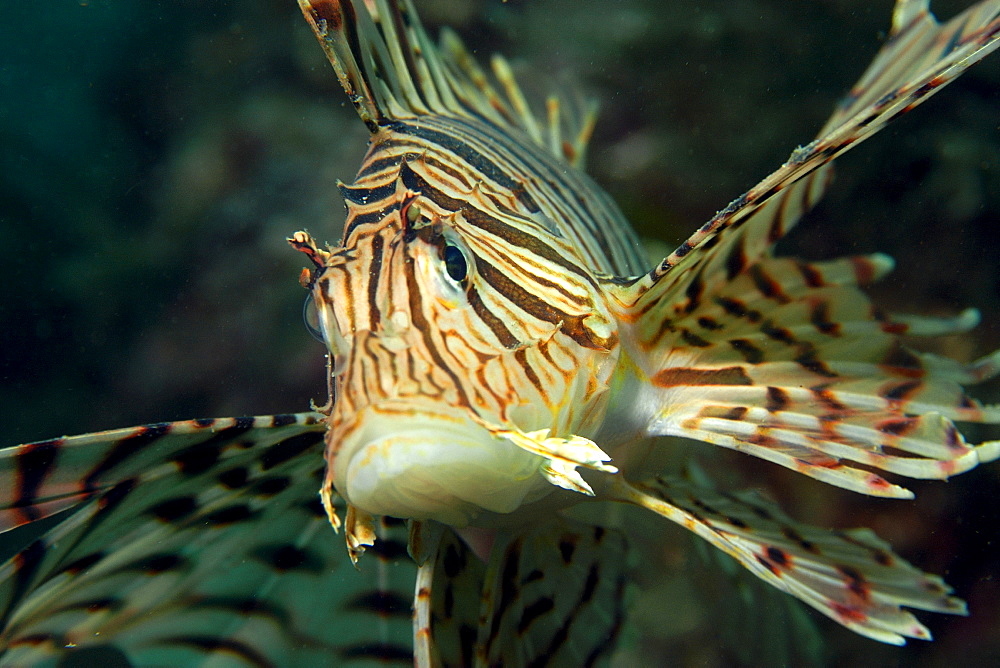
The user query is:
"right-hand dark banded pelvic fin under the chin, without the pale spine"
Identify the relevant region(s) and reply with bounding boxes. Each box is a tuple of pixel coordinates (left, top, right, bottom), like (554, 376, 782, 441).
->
(477, 517, 625, 666)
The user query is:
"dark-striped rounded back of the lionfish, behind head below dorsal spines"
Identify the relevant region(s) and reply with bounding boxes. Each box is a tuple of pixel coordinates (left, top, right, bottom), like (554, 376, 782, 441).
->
(364, 116, 649, 279)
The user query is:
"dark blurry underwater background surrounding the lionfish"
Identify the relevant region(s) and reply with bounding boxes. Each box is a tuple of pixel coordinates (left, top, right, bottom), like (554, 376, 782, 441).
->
(0, 0, 1000, 666)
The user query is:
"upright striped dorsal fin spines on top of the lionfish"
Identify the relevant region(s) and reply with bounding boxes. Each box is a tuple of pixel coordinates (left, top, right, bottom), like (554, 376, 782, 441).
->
(299, 0, 596, 166)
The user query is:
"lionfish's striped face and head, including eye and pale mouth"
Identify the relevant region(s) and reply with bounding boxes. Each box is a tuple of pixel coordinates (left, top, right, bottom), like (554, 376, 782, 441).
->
(291, 146, 617, 526)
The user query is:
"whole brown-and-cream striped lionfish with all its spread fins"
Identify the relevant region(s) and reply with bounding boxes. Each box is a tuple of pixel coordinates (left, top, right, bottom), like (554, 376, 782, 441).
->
(0, 0, 1000, 666)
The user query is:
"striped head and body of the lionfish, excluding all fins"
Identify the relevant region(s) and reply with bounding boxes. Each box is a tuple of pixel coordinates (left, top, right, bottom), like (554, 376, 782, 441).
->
(300, 111, 641, 526)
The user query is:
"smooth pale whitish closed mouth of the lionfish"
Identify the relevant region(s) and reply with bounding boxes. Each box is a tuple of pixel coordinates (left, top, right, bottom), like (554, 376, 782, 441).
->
(336, 404, 554, 527)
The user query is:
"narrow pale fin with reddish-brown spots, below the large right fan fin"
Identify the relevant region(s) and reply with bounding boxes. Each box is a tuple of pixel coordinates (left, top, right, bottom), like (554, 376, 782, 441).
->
(611, 477, 966, 645)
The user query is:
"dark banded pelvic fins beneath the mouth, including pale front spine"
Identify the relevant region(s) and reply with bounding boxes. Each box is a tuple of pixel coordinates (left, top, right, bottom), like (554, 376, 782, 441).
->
(410, 517, 626, 666)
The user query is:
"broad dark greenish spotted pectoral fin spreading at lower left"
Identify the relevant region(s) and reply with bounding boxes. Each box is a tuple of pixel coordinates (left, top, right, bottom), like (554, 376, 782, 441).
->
(0, 413, 413, 666)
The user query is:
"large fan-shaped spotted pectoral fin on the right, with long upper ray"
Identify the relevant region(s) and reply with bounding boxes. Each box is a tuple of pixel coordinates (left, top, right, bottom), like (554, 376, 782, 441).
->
(620, 0, 1000, 498)
